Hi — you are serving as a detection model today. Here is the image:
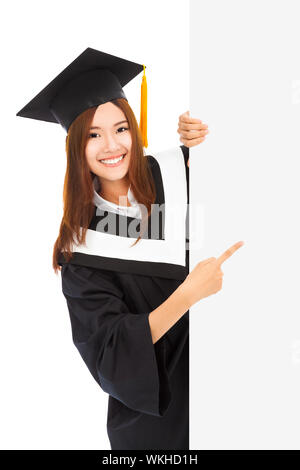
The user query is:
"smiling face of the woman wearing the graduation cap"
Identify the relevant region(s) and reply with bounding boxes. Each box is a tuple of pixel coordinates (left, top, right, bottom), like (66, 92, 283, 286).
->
(85, 102, 132, 183)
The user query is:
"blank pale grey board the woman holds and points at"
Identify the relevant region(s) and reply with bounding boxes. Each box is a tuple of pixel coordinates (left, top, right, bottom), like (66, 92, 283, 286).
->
(190, 0, 300, 449)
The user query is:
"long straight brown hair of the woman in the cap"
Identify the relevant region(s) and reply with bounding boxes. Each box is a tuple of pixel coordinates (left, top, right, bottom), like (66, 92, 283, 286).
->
(53, 98, 156, 274)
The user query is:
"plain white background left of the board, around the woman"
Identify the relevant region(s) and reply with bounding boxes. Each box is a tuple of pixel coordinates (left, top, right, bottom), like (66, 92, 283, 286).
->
(0, 0, 189, 449)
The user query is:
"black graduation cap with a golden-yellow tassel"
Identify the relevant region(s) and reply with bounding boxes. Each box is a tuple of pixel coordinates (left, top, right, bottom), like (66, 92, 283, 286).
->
(16, 47, 148, 147)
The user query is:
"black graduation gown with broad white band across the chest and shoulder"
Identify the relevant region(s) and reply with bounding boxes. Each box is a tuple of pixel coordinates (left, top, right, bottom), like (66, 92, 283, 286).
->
(60, 146, 189, 450)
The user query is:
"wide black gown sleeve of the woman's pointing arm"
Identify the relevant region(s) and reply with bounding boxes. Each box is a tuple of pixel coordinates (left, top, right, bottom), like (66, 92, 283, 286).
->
(61, 263, 171, 416)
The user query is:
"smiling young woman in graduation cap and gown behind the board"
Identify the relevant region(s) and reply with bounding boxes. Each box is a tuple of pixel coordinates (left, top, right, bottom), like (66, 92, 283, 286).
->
(18, 48, 244, 450)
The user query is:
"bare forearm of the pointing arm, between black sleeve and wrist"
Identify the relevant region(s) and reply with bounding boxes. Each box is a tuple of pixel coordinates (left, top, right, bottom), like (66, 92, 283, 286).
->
(149, 284, 192, 343)
